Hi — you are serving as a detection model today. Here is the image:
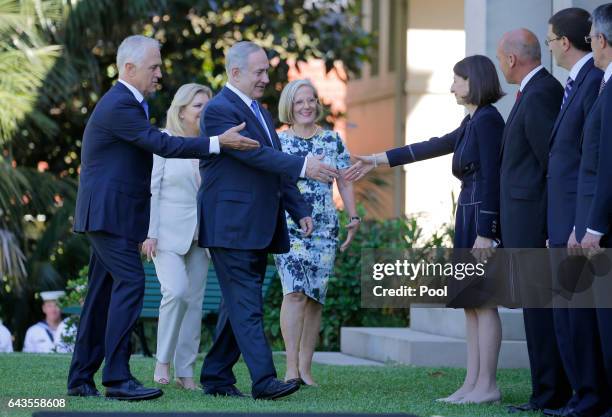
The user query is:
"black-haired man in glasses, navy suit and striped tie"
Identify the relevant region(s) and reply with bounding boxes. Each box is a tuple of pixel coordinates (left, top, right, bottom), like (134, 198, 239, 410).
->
(544, 8, 605, 417)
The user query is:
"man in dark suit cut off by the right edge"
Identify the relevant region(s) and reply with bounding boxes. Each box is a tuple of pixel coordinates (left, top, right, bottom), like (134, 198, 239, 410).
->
(570, 3, 612, 417)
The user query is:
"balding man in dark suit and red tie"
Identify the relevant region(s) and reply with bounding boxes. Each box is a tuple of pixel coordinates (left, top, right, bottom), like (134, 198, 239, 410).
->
(497, 29, 571, 412)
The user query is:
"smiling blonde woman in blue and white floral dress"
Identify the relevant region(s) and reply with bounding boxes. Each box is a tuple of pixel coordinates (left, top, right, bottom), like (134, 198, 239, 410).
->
(275, 80, 361, 385)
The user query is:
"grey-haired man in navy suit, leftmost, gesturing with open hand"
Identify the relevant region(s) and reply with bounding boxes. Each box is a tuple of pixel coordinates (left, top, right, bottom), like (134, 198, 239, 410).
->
(68, 36, 259, 400)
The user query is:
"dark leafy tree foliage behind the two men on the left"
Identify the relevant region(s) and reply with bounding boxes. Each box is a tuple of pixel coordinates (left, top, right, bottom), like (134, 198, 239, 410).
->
(0, 0, 370, 348)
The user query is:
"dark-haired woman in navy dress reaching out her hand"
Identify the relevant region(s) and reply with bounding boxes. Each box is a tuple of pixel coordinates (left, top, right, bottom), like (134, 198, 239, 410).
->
(345, 55, 504, 404)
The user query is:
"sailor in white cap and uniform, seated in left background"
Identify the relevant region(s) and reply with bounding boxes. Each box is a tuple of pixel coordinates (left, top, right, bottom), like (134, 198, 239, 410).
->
(23, 291, 71, 353)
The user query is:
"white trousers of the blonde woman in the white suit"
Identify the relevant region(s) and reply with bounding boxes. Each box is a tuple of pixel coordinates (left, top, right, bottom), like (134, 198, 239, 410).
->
(153, 241, 210, 378)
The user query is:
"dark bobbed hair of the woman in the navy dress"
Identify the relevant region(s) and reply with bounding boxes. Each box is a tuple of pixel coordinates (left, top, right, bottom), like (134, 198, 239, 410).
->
(453, 55, 505, 107)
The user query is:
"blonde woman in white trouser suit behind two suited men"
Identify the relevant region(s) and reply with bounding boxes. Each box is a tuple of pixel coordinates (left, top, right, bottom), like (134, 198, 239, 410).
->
(143, 84, 212, 389)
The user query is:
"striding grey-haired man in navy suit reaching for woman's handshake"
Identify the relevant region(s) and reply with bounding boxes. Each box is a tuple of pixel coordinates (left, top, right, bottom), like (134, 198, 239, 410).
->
(198, 42, 337, 399)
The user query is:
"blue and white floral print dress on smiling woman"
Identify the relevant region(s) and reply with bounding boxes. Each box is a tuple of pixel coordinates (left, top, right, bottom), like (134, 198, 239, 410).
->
(274, 130, 351, 304)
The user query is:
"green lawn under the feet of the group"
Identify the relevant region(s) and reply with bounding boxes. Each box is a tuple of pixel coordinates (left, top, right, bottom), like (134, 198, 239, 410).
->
(0, 353, 538, 417)
